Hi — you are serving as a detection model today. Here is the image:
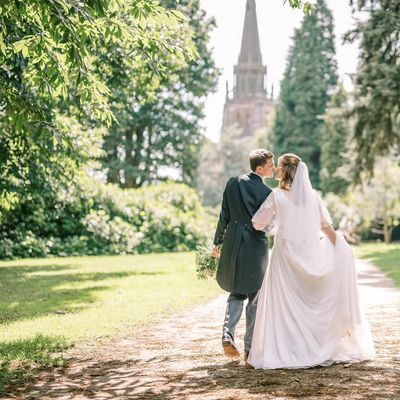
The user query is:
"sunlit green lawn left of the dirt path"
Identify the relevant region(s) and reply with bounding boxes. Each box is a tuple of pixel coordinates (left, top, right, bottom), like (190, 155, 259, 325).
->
(0, 253, 221, 393)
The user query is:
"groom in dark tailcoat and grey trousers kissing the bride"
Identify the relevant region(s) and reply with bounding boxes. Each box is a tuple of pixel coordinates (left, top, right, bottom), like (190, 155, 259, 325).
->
(213, 149, 274, 361)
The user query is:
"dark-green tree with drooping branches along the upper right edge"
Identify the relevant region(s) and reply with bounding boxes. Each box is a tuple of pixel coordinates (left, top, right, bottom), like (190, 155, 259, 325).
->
(346, 0, 400, 181)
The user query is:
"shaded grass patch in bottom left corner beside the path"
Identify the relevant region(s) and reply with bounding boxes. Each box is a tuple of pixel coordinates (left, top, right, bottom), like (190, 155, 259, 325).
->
(0, 335, 69, 395)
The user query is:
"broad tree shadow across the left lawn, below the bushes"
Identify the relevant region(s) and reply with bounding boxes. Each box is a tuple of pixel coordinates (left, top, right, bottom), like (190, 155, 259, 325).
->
(0, 265, 162, 323)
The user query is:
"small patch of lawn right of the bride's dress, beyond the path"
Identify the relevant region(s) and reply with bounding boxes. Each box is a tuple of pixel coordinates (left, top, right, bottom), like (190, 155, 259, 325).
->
(353, 243, 400, 287)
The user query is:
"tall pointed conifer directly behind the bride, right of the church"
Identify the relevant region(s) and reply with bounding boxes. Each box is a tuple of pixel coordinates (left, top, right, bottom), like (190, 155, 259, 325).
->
(274, 0, 337, 187)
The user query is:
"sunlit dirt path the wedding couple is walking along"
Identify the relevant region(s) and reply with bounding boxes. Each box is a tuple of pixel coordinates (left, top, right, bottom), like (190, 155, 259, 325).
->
(5, 262, 400, 400)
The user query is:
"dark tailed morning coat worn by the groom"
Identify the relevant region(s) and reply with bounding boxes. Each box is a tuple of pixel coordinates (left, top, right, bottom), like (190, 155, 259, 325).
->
(214, 172, 271, 294)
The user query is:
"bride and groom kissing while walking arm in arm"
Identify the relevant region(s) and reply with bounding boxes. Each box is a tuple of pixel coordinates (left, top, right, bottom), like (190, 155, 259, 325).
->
(213, 149, 375, 369)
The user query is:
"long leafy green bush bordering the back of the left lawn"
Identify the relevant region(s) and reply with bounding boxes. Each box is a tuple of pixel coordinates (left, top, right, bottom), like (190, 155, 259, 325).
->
(0, 174, 215, 259)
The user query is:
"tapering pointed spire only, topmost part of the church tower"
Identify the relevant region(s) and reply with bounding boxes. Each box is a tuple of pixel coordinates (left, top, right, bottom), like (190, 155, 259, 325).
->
(239, 0, 262, 64)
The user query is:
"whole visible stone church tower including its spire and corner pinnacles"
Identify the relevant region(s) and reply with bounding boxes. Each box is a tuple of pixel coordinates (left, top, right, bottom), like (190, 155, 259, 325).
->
(222, 0, 274, 136)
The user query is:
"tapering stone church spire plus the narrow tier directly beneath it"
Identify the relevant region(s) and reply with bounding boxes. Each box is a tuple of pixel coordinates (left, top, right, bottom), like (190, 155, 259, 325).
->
(234, 0, 267, 98)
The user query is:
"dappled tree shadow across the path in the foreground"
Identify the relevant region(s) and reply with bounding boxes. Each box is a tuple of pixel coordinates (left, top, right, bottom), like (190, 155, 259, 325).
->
(10, 355, 400, 400)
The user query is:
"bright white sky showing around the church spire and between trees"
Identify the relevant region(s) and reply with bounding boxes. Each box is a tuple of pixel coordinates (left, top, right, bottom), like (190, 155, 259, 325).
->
(200, 0, 358, 141)
